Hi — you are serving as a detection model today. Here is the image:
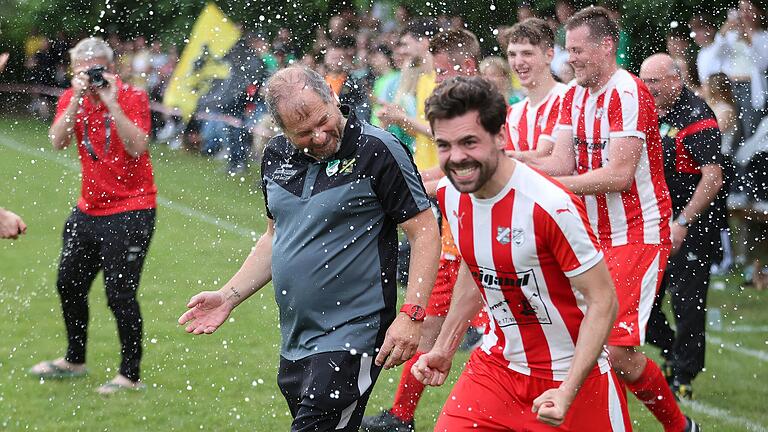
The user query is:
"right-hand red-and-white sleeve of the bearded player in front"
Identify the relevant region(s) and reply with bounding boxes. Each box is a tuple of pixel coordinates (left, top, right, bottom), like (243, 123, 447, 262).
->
(534, 193, 603, 277)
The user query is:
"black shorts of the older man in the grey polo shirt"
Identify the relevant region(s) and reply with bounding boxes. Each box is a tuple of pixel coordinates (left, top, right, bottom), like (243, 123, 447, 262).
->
(277, 351, 381, 432)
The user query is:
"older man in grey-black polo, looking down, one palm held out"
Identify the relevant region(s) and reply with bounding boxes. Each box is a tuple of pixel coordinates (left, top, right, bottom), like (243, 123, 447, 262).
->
(179, 67, 440, 432)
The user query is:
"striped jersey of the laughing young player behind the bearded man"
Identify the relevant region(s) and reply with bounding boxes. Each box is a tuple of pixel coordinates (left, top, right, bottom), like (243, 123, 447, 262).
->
(506, 83, 568, 151)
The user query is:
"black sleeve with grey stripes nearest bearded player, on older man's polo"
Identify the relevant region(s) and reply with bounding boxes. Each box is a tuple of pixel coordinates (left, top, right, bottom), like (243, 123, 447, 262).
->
(372, 136, 431, 224)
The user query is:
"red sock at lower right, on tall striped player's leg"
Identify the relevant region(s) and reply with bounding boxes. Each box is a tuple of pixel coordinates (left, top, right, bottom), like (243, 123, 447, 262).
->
(626, 359, 688, 432)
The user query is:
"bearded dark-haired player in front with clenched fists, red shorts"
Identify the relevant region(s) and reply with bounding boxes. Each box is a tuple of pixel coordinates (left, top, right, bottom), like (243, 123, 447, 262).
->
(411, 77, 631, 431)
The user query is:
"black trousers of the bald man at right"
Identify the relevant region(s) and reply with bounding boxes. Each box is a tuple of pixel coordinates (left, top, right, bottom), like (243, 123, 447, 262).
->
(646, 223, 720, 383)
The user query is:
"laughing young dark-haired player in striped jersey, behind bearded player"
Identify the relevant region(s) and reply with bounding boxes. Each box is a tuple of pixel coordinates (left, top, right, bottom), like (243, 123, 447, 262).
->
(504, 18, 568, 156)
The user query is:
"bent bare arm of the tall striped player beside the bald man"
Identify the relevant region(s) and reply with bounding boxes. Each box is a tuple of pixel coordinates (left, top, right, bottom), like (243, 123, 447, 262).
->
(558, 137, 644, 195)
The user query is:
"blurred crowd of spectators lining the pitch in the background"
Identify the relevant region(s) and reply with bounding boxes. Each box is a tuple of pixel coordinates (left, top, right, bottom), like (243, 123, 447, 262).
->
(16, 0, 768, 274)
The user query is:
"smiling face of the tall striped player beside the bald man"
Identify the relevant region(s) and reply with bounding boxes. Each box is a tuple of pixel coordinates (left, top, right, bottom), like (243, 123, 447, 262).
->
(565, 25, 614, 88)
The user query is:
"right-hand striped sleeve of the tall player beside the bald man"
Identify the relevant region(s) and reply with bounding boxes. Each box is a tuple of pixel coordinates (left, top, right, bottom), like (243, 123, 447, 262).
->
(608, 85, 654, 140)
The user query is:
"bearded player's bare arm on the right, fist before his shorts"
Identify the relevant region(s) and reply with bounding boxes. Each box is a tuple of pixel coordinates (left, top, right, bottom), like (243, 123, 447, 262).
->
(533, 260, 619, 426)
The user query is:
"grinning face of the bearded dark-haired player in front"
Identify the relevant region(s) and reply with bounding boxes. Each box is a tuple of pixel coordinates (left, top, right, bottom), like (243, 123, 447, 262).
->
(432, 111, 505, 195)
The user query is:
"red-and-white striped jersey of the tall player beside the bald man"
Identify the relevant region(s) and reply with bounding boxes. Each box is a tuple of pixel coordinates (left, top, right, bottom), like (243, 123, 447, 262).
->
(556, 69, 672, 247)
